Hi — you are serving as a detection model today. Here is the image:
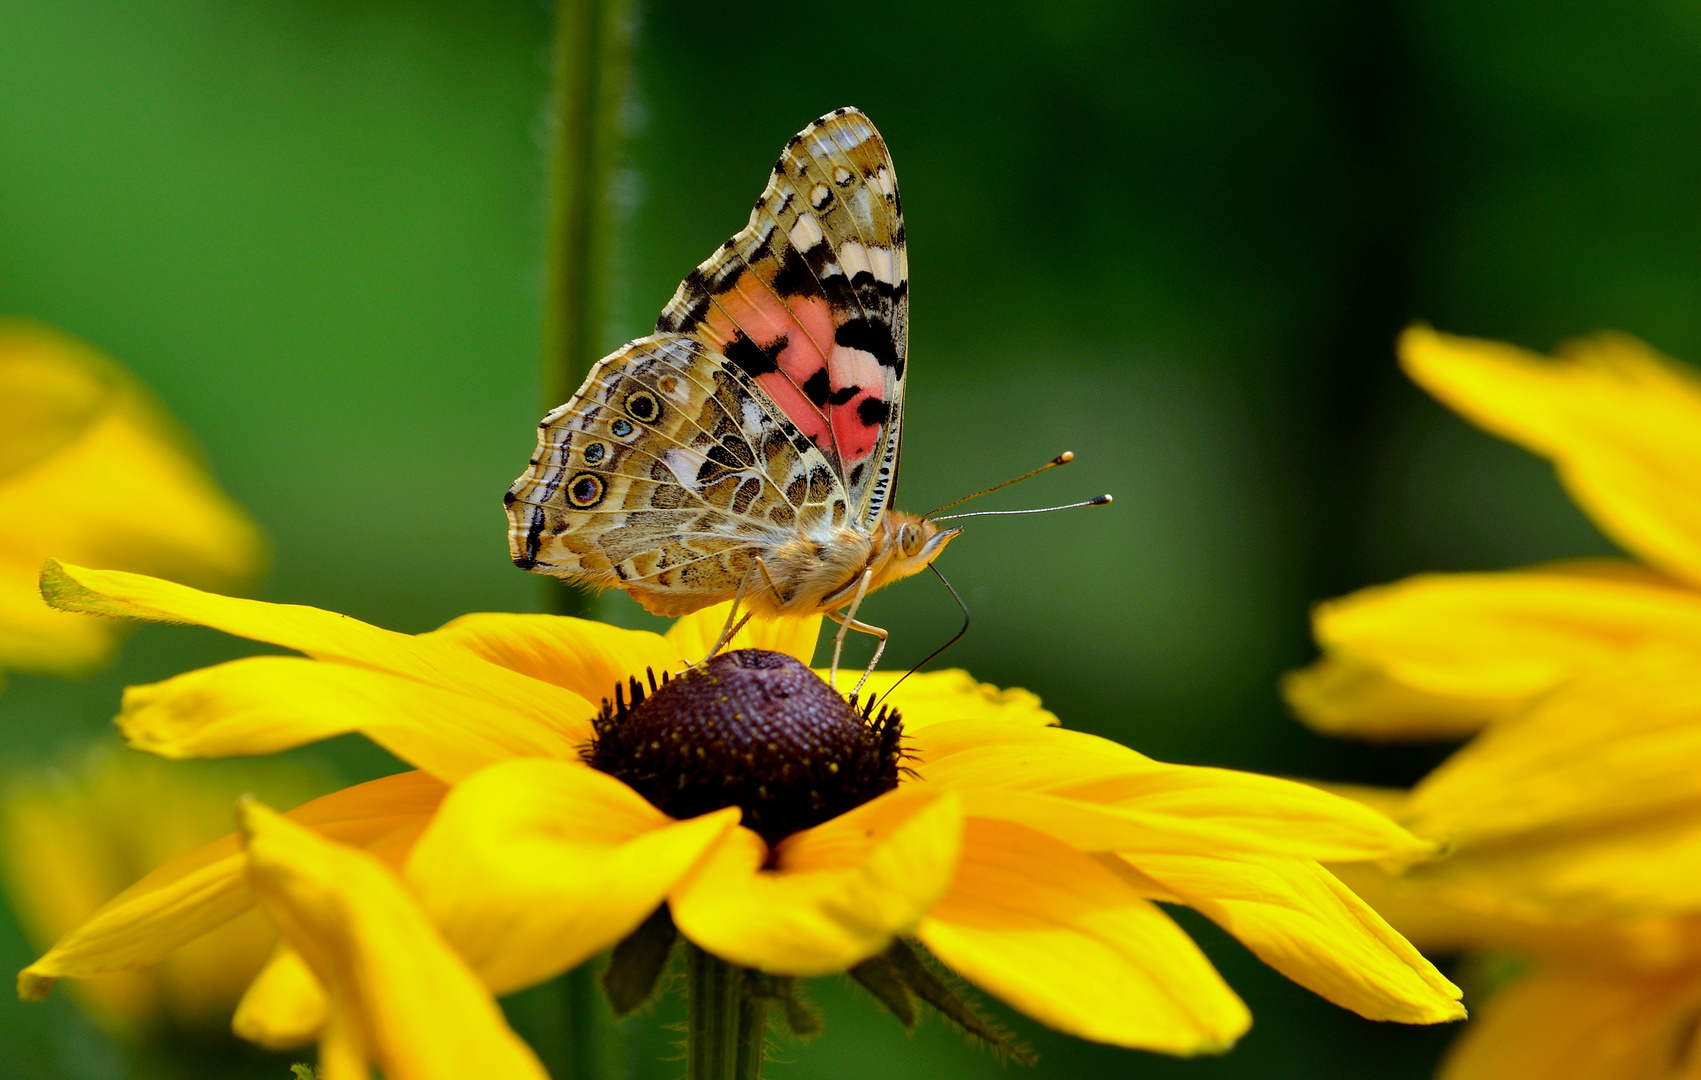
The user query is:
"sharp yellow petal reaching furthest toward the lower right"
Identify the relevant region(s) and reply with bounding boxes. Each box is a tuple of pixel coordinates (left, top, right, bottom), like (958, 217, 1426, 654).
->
(1126, 855, 1465, 1024)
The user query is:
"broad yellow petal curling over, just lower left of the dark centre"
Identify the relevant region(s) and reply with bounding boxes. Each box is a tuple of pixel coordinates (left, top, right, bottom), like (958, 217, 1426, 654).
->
(407, 760, 738, 993)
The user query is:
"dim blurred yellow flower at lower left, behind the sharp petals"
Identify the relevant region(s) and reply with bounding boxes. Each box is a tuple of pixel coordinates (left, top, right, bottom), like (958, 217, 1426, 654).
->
(0, 747, 315, 1037)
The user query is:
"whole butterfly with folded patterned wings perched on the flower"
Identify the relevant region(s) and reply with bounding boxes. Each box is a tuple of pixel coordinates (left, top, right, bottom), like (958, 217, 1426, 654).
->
(507, 109, 961, 683)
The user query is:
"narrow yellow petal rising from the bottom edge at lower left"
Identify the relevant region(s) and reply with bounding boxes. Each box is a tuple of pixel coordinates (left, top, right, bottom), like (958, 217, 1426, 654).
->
(240, 803, 548, 1080)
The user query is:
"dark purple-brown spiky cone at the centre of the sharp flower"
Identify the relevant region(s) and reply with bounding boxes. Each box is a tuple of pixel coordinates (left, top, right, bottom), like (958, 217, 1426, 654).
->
(585, 648, 902, 844)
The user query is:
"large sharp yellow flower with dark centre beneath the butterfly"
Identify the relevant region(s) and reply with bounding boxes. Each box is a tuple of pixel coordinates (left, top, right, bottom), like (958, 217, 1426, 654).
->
(19, 566, 1463, 1075)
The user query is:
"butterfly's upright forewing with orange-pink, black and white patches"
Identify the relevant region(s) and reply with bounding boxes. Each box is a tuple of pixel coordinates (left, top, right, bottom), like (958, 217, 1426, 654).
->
(657, 109, 910, 531)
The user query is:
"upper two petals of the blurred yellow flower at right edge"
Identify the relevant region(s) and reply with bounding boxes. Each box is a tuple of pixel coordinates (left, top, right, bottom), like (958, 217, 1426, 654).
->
(1284, 327, 1701, 740)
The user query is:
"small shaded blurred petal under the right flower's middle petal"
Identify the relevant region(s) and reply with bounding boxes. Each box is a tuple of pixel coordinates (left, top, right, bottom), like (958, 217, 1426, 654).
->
(1281, 657, 1512, 742)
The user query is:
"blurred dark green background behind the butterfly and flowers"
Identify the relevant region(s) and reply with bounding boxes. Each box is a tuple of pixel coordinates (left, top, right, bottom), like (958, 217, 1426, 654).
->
(0, 0, 1701, 1080)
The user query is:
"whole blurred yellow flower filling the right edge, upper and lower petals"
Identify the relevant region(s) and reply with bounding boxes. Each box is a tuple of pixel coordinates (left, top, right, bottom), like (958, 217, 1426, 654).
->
(1284, 328, 1701, 1080)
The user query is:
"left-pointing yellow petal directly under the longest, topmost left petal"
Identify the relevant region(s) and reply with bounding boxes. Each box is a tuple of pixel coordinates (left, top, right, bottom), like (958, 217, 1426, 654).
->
(117, 657, 590, 782)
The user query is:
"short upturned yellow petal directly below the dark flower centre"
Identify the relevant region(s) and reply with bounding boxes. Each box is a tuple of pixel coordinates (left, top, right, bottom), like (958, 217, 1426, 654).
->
(670, 791, 963, 975)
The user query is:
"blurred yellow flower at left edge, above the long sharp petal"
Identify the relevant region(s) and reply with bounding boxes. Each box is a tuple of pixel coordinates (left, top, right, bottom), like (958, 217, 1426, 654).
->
(0, 320, 265, 675)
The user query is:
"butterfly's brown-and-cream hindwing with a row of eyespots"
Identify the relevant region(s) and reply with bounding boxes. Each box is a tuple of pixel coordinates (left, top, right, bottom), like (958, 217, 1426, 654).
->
(507, 333, 851, 616)
